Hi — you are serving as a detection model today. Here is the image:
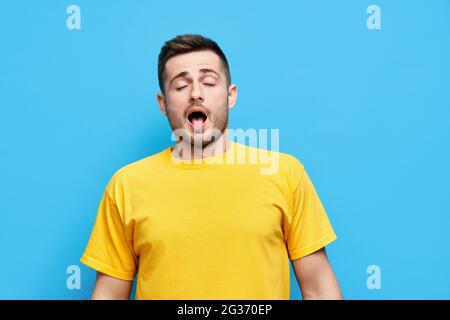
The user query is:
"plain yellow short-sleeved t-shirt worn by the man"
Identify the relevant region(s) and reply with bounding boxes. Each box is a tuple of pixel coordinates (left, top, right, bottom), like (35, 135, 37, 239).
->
(80, 141, 336, 300)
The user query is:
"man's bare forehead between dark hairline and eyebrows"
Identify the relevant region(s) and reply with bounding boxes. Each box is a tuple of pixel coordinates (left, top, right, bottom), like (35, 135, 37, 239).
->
(165, 51, 222, 80)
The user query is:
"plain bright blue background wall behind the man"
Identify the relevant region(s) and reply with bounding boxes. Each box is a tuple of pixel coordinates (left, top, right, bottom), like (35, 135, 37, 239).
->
(0, 0, 450, 299)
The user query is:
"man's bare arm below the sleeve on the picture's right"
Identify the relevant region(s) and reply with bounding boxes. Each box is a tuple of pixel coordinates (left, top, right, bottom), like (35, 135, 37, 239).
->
(292, 247, 343, 300)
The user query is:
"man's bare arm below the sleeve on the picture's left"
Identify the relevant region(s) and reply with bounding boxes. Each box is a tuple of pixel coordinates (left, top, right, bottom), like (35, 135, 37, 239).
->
(91, 272, 133, 300)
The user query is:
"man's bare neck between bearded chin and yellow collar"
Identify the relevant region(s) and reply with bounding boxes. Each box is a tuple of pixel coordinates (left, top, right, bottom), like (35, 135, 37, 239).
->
(171, 129, 229, 160)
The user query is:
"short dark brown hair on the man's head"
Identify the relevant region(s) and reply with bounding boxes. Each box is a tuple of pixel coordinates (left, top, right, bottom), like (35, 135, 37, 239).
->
(158, 34, 231, 93)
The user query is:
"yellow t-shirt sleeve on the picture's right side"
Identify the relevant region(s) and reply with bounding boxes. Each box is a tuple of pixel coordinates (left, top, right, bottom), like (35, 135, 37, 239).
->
(284, 165, 337, 260)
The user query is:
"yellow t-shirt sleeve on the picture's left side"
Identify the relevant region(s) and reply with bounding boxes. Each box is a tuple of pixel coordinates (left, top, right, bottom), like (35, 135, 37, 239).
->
(80, 190, 137, 280)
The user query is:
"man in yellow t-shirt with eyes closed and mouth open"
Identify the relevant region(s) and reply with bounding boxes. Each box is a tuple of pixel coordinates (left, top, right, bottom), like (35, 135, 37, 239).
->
(81, 34, 342, 299)
